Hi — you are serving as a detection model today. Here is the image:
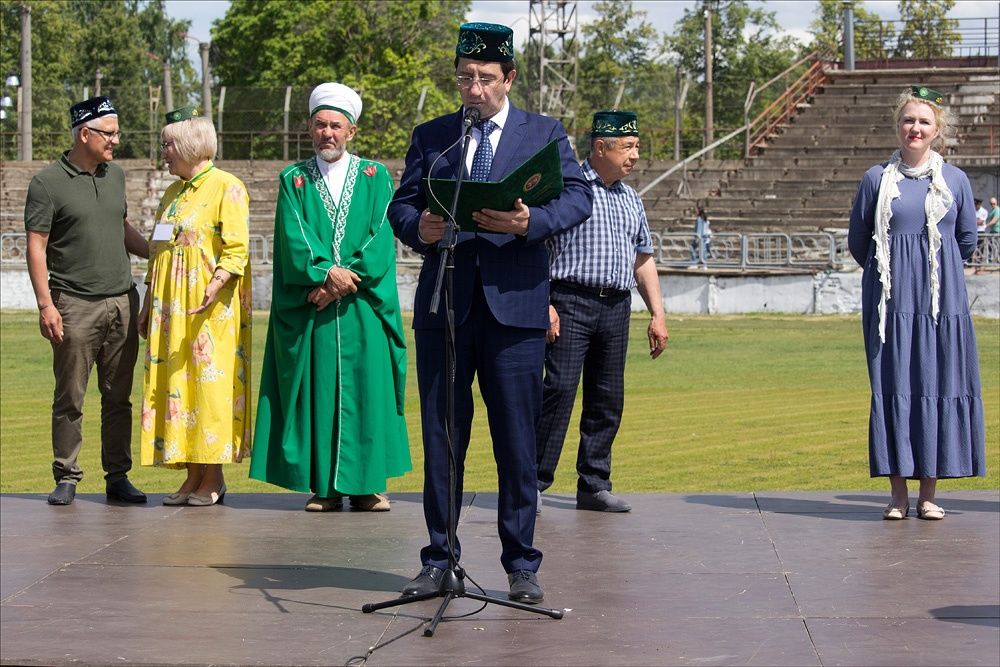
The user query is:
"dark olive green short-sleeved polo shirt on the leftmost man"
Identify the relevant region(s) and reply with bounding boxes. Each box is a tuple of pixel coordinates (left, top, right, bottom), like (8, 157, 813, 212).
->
(24, 151, 132, 296)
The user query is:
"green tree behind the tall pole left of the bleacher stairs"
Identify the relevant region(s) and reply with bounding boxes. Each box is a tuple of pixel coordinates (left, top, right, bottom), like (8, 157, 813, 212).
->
(667, 0, 801, 157)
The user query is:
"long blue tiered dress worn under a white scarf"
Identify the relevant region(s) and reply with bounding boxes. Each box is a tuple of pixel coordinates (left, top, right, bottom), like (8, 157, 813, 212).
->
(848, 162, 986, 479)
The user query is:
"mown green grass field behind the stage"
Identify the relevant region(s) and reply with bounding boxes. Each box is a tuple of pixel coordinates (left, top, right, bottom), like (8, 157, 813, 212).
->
(0, 311, 1000, 493)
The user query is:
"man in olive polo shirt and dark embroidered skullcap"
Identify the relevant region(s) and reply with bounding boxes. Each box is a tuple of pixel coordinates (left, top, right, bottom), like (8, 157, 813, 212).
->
(24, 97, 149, 505)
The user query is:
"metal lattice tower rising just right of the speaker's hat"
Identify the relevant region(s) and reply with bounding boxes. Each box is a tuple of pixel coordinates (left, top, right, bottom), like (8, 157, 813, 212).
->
(528, 0, 578, 136)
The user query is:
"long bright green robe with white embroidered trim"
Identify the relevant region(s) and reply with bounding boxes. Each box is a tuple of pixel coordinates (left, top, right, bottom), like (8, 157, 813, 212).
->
(250, 153, 411, 497)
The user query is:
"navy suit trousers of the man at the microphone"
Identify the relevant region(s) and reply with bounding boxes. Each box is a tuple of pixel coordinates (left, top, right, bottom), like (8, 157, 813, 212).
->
(414, 285, 545, 572)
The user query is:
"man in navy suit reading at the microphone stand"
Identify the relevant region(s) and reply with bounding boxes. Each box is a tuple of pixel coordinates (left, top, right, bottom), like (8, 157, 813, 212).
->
(388, 23, 593, 603)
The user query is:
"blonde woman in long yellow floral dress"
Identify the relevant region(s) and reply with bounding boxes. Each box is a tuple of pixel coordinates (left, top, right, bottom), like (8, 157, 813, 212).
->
(139, 107, 251, 506)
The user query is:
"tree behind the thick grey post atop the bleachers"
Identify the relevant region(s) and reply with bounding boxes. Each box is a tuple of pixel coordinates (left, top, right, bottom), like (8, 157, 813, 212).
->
(809, 0, 896, 60)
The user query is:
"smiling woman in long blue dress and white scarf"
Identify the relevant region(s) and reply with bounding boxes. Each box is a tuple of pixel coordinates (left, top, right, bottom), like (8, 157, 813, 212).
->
(848, 86, 986, 519)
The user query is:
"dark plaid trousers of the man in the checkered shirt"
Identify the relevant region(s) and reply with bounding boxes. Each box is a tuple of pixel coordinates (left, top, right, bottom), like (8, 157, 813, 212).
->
(537, 284, 631, 492)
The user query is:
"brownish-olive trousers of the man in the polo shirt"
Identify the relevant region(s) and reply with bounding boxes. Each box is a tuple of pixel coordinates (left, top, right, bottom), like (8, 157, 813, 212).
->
(52, 288, 139, 483)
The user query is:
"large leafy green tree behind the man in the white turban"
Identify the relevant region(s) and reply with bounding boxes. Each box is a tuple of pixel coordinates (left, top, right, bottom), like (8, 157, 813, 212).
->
(212, 0, 470, 158)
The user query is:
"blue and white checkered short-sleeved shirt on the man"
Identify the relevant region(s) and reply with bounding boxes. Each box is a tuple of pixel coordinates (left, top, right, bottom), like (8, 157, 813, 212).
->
(547, 159, 653, 290)
